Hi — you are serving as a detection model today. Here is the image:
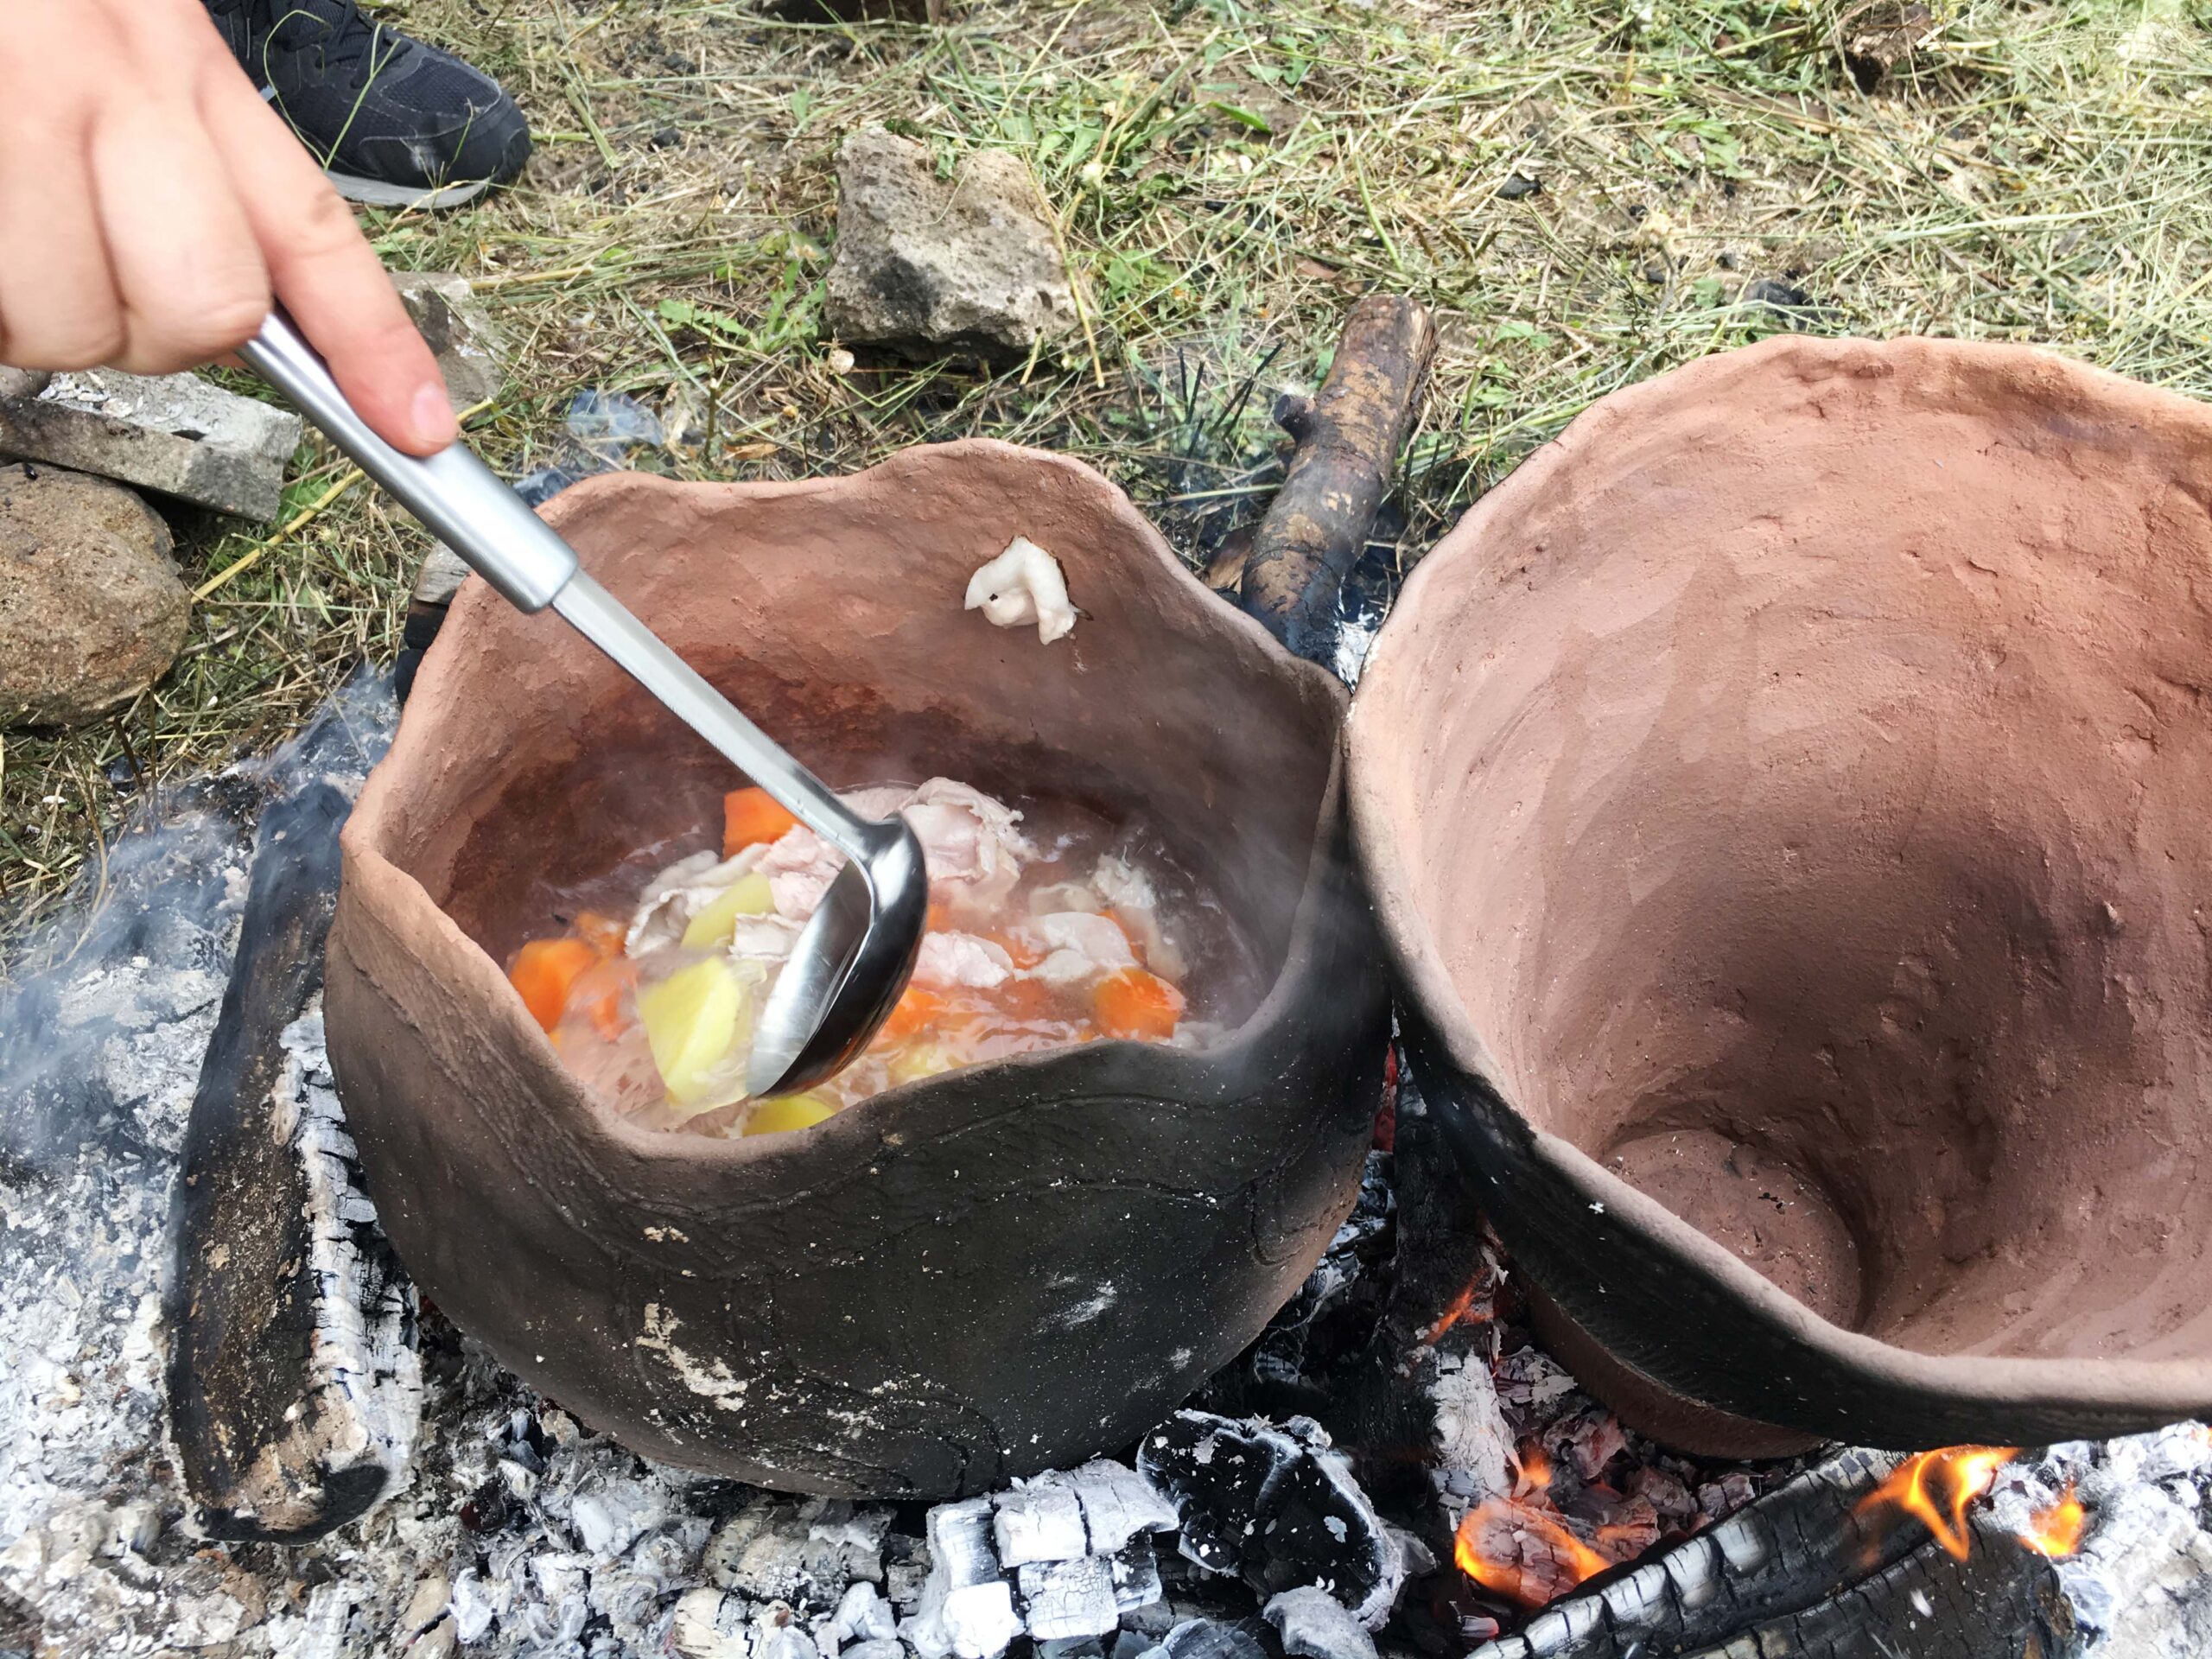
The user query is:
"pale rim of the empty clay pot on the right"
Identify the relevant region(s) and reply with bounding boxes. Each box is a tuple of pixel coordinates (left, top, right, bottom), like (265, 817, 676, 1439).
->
(1344, 334, 2212, 1421)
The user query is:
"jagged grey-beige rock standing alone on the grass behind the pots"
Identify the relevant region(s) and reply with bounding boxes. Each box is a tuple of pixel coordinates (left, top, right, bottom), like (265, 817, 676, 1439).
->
(827, 126, 1075, 363)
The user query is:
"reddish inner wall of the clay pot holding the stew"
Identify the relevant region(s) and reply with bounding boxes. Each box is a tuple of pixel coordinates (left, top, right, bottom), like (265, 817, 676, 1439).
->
(387, 462, 1338, 1065)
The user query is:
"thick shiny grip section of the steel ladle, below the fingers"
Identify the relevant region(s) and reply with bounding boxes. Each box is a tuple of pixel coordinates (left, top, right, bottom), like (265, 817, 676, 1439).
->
(238, 309, 577, 611)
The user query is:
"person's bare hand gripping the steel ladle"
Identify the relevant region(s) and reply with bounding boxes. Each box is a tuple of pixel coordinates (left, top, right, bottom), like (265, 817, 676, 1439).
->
(0, 0, 455, 455)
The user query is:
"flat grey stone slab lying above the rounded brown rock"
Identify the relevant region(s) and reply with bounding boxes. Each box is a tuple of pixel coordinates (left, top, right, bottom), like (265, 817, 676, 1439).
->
(0, 370, 301, 524)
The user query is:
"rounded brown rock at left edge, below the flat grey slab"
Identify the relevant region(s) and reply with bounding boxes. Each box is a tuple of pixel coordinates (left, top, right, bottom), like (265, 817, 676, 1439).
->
(0, 467, 193, 728)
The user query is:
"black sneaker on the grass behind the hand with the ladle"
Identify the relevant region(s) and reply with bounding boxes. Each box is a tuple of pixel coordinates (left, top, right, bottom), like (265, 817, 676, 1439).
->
(206, 0, 531, 208)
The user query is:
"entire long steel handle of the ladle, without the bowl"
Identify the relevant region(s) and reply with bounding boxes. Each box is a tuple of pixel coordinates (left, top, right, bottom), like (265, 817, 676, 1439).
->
(238, 309, 882, 861)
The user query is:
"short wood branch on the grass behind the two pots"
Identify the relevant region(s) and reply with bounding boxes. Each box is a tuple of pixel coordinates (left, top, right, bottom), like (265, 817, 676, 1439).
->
(1239, 294, 1435, 661)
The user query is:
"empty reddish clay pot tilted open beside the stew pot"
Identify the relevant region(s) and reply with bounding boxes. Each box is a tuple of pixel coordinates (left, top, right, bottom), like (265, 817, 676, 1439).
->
(1350, 339, 2212, 1451)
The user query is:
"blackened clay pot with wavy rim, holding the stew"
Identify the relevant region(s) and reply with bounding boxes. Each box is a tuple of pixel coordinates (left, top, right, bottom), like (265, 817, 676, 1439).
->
(327, 442, 1387, 1497)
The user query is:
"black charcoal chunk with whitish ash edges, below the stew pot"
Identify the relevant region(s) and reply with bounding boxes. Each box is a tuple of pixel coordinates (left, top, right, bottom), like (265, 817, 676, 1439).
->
(1137, 1411, 1405, 1628)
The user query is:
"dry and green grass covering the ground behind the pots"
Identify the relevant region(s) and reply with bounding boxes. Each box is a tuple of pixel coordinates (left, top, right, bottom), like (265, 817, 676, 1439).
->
(0, 0, 2212, 971)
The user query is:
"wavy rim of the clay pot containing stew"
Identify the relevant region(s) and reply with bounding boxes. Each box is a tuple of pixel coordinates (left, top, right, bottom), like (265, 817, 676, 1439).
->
(339, 438, 1350, 1174)
